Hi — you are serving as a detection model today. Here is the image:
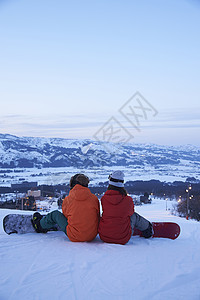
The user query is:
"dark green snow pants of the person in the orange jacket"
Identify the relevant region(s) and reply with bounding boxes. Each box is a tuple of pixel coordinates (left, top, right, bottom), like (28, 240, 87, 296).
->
(40, 210, 68, 234)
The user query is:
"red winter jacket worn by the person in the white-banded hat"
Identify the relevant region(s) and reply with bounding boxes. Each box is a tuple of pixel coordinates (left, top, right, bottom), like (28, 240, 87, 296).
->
(99, 190, 134, 245)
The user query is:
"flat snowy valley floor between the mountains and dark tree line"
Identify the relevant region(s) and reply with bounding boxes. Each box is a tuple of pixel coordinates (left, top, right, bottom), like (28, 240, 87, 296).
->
(0, 160, 200, 186)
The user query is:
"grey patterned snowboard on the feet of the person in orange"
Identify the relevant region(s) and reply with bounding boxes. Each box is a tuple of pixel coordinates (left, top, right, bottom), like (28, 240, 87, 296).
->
(3, 214, 61, 234)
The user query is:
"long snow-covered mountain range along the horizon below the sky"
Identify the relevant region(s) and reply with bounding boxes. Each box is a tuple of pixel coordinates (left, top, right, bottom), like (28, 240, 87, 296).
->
(0, 134, 200, 168)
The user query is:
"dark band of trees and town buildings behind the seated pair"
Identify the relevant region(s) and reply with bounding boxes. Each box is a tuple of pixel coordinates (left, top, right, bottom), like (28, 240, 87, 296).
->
(0, 178, 200, 211)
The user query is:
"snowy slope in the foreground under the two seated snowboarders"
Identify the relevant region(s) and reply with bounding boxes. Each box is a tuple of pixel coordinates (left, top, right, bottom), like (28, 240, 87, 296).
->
(0, 200, 200, 300)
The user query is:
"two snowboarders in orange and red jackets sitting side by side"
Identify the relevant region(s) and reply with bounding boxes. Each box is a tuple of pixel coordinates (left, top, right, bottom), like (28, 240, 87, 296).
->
(32, 171, 153, 244)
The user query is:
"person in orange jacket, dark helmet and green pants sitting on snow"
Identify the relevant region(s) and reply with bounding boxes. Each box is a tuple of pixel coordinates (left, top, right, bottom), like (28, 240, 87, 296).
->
(32, 174, 100, 242)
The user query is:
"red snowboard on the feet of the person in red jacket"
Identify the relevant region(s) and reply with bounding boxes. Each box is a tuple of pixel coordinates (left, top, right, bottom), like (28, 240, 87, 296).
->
(133, 222, 181, 240)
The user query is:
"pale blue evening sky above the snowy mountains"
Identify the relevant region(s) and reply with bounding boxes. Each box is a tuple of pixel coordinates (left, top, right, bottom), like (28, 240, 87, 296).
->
(0, 0, 200, 146)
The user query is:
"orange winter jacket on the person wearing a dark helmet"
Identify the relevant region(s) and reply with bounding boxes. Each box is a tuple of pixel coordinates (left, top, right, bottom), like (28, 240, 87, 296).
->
(62, 184, 100, 242)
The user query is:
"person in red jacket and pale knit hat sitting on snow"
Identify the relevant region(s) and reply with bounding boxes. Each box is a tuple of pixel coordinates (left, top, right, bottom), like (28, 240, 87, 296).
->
(98, 170, 153, 245)
